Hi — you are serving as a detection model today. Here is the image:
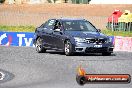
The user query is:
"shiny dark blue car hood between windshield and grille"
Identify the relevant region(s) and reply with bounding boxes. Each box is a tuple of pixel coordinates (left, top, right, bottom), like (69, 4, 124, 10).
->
(65, 31, 107, 38)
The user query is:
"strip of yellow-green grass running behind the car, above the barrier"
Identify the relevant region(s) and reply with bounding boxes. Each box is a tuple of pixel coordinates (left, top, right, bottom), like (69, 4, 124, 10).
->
(0, 25, 132, 37)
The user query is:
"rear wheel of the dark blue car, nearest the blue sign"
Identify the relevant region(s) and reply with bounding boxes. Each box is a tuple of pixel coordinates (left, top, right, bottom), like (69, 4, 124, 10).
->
(35, 37, 46, 53)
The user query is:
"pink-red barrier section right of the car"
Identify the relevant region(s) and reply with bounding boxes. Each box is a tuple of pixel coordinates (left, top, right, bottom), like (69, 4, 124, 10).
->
(114, 36, 132, 52)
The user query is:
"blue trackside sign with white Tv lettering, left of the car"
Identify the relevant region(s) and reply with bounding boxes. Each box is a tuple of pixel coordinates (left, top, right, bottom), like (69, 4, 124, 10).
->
(0, 32, 34, 46)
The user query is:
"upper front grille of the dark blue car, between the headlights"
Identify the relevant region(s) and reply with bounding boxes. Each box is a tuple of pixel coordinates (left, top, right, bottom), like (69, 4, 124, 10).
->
(85, 38, 107, 44)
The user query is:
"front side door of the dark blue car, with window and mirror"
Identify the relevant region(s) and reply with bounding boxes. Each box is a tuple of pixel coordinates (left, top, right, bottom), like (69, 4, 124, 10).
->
(52, 20, 65, 50)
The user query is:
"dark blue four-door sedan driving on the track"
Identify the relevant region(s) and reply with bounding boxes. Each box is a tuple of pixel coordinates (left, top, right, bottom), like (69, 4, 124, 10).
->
(33, 18, 114, 56)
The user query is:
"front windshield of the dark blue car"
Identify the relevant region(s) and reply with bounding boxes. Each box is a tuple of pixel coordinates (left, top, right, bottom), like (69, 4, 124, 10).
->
(63, 20, 97, 32)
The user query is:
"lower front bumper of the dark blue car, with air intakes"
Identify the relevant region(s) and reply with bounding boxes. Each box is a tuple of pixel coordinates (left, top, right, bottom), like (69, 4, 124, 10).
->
(75, 44, 114, 53)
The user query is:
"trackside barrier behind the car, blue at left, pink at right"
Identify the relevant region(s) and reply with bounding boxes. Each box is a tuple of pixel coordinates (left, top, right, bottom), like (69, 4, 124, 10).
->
(0, 32, 132, 52)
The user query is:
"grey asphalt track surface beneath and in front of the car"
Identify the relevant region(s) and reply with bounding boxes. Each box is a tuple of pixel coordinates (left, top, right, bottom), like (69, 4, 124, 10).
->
(0, 46, 132, 88)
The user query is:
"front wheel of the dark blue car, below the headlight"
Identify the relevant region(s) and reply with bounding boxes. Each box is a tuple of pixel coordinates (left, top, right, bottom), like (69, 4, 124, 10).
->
(64, 40, 73, 56)
